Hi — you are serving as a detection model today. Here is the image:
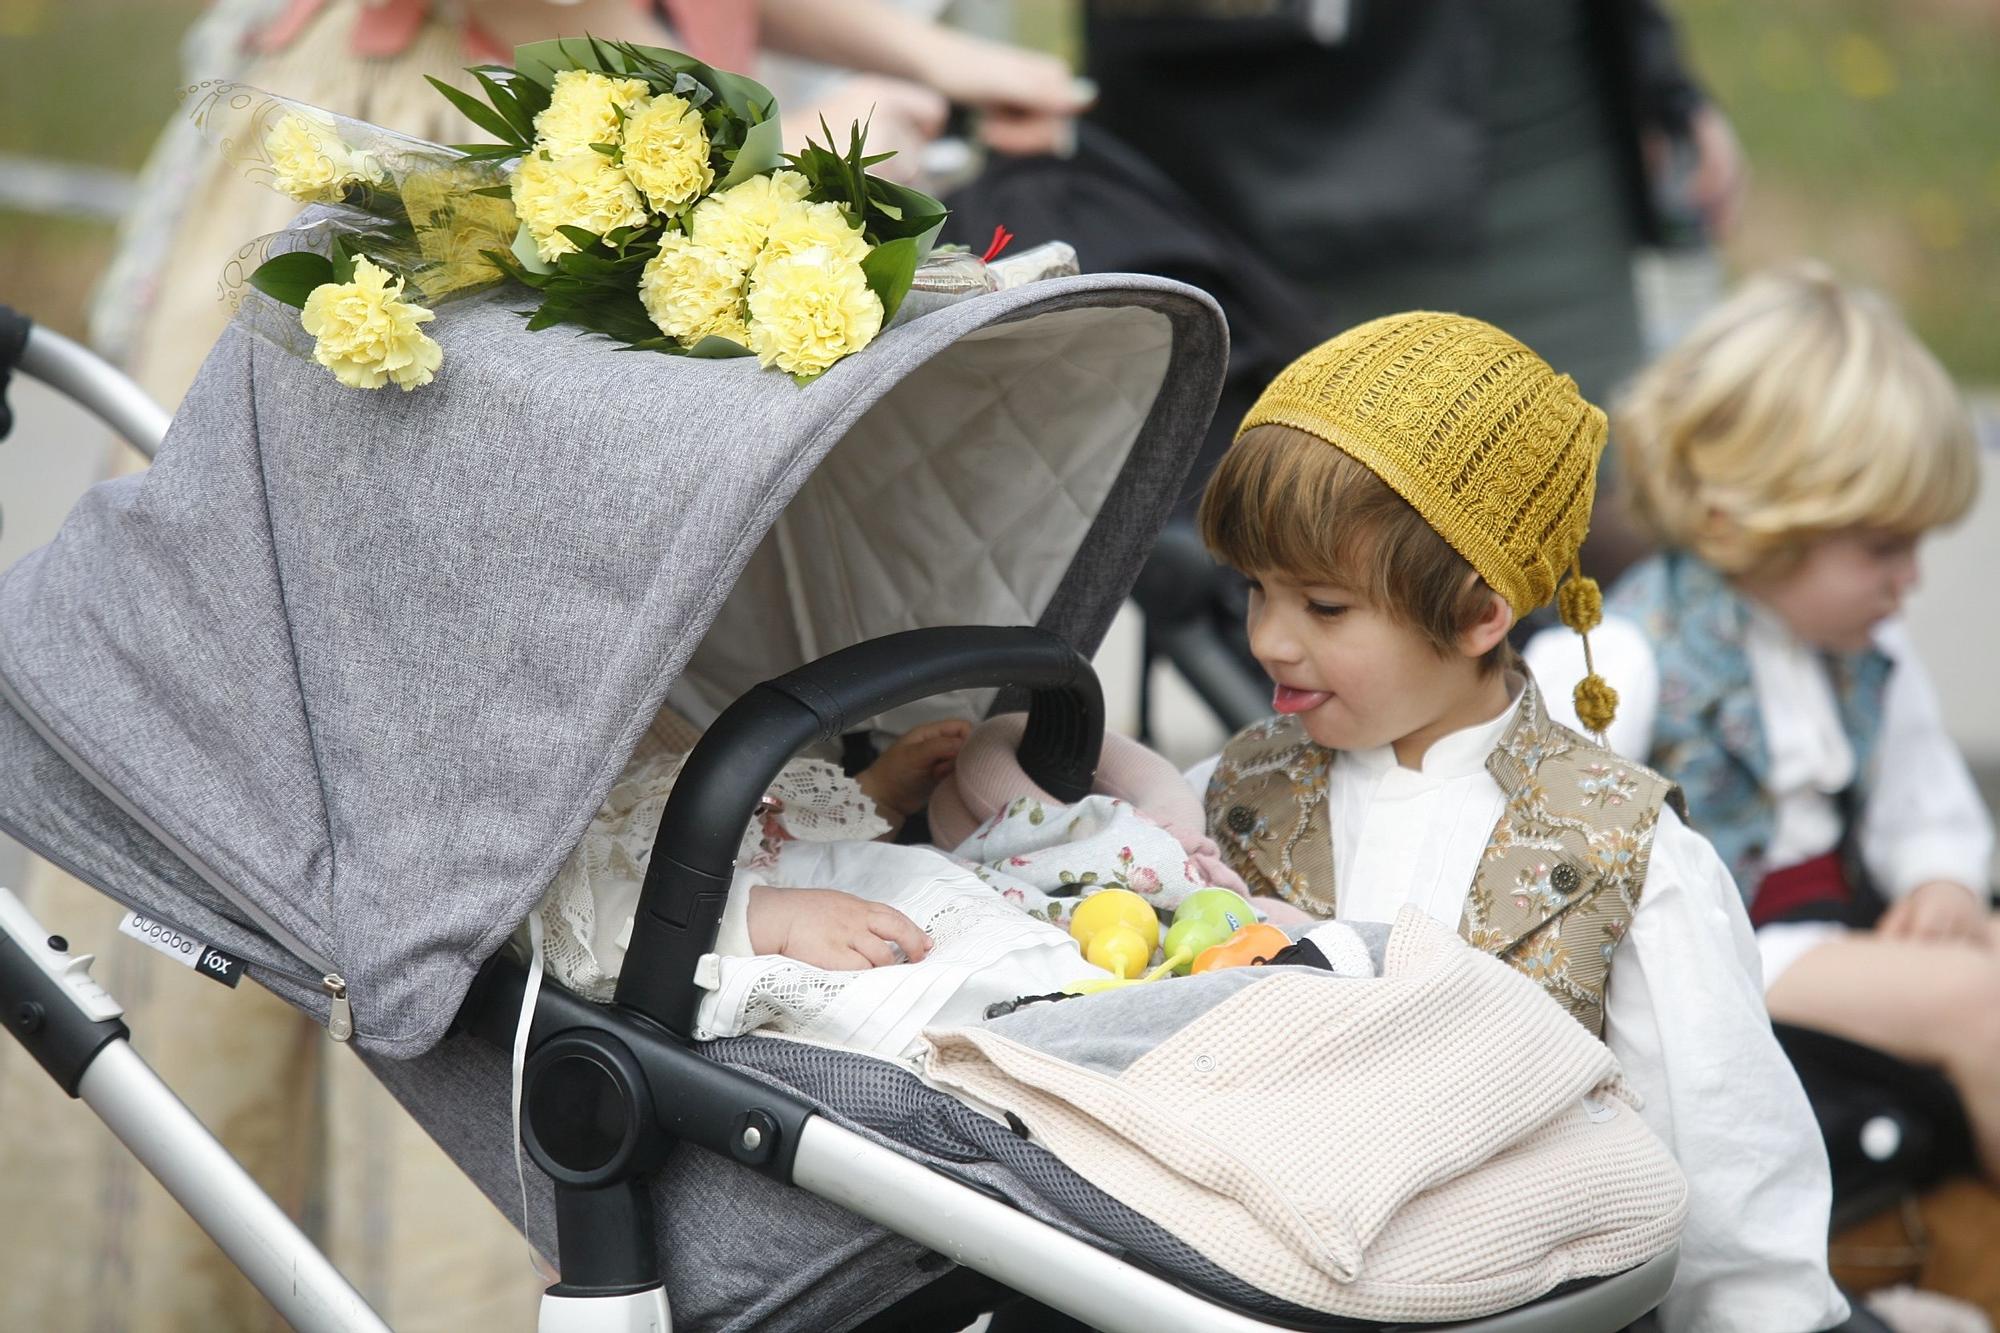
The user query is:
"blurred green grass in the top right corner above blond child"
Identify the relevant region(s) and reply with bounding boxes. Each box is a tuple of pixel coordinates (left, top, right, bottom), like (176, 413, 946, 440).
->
(1676, 0, 2000, 384)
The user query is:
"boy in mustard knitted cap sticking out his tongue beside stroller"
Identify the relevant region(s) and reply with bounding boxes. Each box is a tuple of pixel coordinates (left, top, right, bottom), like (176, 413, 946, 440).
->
(1190, 312, 1844, 1333)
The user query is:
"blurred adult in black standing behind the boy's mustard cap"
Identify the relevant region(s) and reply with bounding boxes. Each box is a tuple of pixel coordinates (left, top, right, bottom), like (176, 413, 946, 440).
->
(1086, 0, 1744, 576)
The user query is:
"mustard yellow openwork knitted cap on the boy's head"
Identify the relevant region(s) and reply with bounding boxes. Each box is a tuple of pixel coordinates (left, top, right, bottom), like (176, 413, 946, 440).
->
(1236, 310, 1604, 616)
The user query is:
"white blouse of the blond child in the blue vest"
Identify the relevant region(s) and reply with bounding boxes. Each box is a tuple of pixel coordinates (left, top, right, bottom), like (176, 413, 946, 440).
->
(1526, 610, 1994, 904)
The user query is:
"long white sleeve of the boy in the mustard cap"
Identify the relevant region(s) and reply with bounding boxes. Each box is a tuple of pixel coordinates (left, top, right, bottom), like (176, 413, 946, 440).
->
(1604, 809, 1846, 1333)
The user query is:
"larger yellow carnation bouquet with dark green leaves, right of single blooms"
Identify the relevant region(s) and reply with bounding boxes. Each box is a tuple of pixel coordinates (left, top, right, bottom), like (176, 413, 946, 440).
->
(456, 38, 946, 382)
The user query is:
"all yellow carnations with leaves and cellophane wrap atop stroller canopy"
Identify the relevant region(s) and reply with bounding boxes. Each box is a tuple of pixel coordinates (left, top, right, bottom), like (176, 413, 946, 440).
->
(192, 38, 946, 390)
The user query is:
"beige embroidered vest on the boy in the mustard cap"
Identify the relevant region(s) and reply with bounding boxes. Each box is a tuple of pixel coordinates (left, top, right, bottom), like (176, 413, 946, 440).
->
(1206, 681, 1684, 1037)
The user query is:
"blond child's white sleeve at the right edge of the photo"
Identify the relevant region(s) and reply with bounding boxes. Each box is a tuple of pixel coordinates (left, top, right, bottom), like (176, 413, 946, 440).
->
(1860, 622, 1994, 899)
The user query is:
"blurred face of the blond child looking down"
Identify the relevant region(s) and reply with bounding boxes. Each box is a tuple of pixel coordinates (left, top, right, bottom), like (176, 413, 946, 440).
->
(1744, 528, 1918, 652)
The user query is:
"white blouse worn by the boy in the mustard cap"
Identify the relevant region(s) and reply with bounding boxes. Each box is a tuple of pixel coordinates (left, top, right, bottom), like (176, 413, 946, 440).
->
(1188, 688, 1846, 1333)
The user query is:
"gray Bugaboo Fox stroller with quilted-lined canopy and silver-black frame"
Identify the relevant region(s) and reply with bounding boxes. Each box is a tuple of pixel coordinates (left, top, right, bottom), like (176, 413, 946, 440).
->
(0, 276, 1674, 1333)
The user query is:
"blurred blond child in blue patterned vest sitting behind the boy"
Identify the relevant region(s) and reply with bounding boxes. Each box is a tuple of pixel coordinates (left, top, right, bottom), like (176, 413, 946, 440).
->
(1528, 264, 2000, 1173)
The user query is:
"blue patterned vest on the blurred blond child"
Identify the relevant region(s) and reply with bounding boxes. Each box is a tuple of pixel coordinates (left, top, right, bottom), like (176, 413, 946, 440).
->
(1604, 552, 1890, 903)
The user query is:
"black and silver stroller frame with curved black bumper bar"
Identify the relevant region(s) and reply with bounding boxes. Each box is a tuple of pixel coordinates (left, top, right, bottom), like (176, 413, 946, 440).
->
(0, 314, 1676, 1333)
